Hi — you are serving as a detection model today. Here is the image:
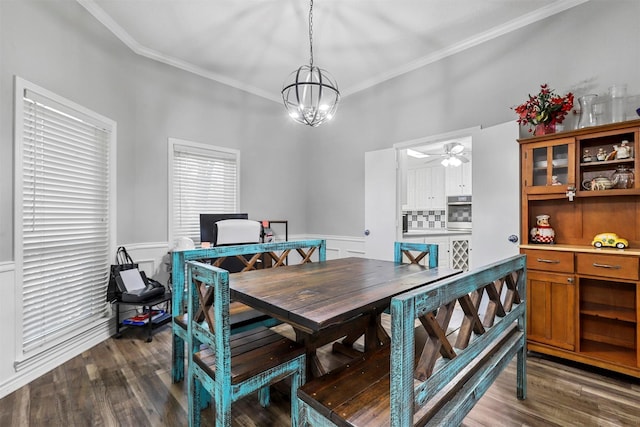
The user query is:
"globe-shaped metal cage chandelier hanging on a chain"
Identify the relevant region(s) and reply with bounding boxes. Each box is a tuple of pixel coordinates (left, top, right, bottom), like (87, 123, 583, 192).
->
(282, 0, 340, 127)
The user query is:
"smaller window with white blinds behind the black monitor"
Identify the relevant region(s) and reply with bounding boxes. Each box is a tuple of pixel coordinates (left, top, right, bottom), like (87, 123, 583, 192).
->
(169, 138, 240, 245)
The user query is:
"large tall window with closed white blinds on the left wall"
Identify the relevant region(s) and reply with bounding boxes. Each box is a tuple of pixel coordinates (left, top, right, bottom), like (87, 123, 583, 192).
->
(15, 78, 116, 357)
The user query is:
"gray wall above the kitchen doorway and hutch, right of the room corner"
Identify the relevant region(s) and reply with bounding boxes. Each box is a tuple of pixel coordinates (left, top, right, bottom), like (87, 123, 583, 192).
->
(307, 0, 640, 236)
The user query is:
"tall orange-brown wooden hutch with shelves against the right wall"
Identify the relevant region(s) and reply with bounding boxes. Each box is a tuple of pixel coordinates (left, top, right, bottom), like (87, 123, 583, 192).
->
(518, 120, 640, 377)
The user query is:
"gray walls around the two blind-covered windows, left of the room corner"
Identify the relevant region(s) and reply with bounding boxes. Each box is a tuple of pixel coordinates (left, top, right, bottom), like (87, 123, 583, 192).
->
(0, 0, 307, 262)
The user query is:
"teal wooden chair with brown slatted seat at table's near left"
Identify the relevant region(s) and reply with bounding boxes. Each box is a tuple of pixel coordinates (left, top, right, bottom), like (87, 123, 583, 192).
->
(186, 261, 306, 427)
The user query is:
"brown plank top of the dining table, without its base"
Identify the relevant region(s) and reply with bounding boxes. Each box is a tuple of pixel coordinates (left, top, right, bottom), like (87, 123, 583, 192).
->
(229, 258, 461, 333)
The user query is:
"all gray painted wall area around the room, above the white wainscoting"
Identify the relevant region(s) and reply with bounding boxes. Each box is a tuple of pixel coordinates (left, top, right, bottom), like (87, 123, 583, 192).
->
(0, 0, 640, 262)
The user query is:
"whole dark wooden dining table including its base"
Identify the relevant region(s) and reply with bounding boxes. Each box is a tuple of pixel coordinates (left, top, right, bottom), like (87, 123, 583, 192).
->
(229, 257, 462, 378)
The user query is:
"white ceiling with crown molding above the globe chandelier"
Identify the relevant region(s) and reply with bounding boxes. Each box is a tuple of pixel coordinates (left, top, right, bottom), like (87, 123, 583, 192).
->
(77, 0, 587, 102)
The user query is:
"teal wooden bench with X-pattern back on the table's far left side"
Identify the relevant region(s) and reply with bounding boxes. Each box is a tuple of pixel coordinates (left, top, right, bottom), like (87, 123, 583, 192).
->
(171, 239, 326, 383)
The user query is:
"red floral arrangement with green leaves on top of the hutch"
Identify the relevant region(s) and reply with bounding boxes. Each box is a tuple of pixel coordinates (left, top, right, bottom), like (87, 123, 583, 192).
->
(513, 83, 573, 132)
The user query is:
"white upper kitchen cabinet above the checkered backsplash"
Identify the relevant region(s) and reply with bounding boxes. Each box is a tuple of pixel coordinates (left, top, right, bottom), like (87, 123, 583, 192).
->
(403, 166, 445, 210)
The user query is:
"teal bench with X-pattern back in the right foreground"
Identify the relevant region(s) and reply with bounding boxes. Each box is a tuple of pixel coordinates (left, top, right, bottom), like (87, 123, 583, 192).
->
(298, 255, 526, 427)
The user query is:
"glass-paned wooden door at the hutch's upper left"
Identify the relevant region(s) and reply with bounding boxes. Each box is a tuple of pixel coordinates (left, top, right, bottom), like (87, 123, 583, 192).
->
(523, 138, 575, 193)
